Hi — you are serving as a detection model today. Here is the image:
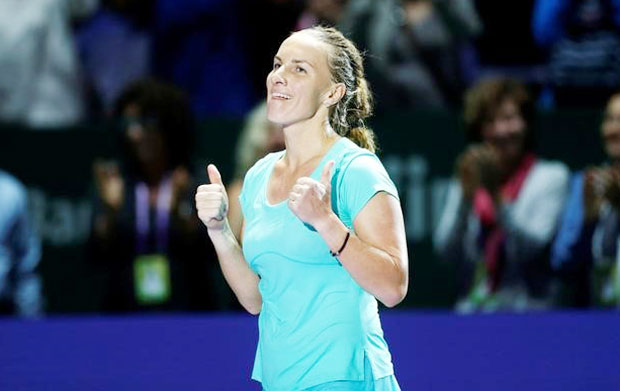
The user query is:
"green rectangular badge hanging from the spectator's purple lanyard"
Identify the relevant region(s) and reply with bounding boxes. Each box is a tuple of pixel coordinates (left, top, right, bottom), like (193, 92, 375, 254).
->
(133, 254, 170, 305)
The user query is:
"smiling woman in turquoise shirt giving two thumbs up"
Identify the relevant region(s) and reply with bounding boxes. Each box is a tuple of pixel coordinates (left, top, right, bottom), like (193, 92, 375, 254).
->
(196, 27, 408, 391)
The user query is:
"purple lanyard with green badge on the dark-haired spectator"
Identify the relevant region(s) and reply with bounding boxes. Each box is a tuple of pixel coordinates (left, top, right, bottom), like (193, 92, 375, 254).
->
(133, 178, 172, 305)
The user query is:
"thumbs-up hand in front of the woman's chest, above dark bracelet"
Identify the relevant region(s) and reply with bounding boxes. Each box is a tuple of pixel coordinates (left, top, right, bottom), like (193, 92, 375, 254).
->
(288, 160, 334, 227)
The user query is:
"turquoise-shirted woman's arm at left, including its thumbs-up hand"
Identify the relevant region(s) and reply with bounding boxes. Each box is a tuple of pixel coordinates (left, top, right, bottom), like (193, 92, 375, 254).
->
(196, 164, 262, 315)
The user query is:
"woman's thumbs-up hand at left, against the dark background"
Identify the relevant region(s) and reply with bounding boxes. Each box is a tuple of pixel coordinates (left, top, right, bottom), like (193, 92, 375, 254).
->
(196, 164, 228, 230)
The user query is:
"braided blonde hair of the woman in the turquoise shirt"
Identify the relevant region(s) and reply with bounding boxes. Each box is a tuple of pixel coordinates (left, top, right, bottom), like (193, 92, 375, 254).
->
(306, 26, 376, 152)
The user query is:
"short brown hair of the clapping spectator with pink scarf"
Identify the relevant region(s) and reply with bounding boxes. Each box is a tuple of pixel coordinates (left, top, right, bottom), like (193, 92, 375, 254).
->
(465, 77, 534, 142)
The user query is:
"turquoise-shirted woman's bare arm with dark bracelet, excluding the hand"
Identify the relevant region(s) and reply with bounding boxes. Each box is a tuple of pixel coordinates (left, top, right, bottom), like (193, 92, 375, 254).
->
(315, 192, 409, 307)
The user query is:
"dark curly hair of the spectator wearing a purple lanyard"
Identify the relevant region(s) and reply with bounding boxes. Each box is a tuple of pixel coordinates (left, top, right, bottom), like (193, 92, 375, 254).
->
(114, 79, 194, 169)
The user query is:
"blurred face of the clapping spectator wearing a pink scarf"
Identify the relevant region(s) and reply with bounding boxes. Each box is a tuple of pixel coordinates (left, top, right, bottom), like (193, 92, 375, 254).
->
(482, 99, 526, 168)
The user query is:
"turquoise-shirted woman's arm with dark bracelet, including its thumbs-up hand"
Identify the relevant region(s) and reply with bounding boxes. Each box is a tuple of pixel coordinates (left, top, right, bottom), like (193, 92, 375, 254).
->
(288, 159, 409, 307)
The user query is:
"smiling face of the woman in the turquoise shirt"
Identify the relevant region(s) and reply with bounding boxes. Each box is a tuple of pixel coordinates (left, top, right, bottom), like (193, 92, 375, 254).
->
(267, 32, 333, 126)
